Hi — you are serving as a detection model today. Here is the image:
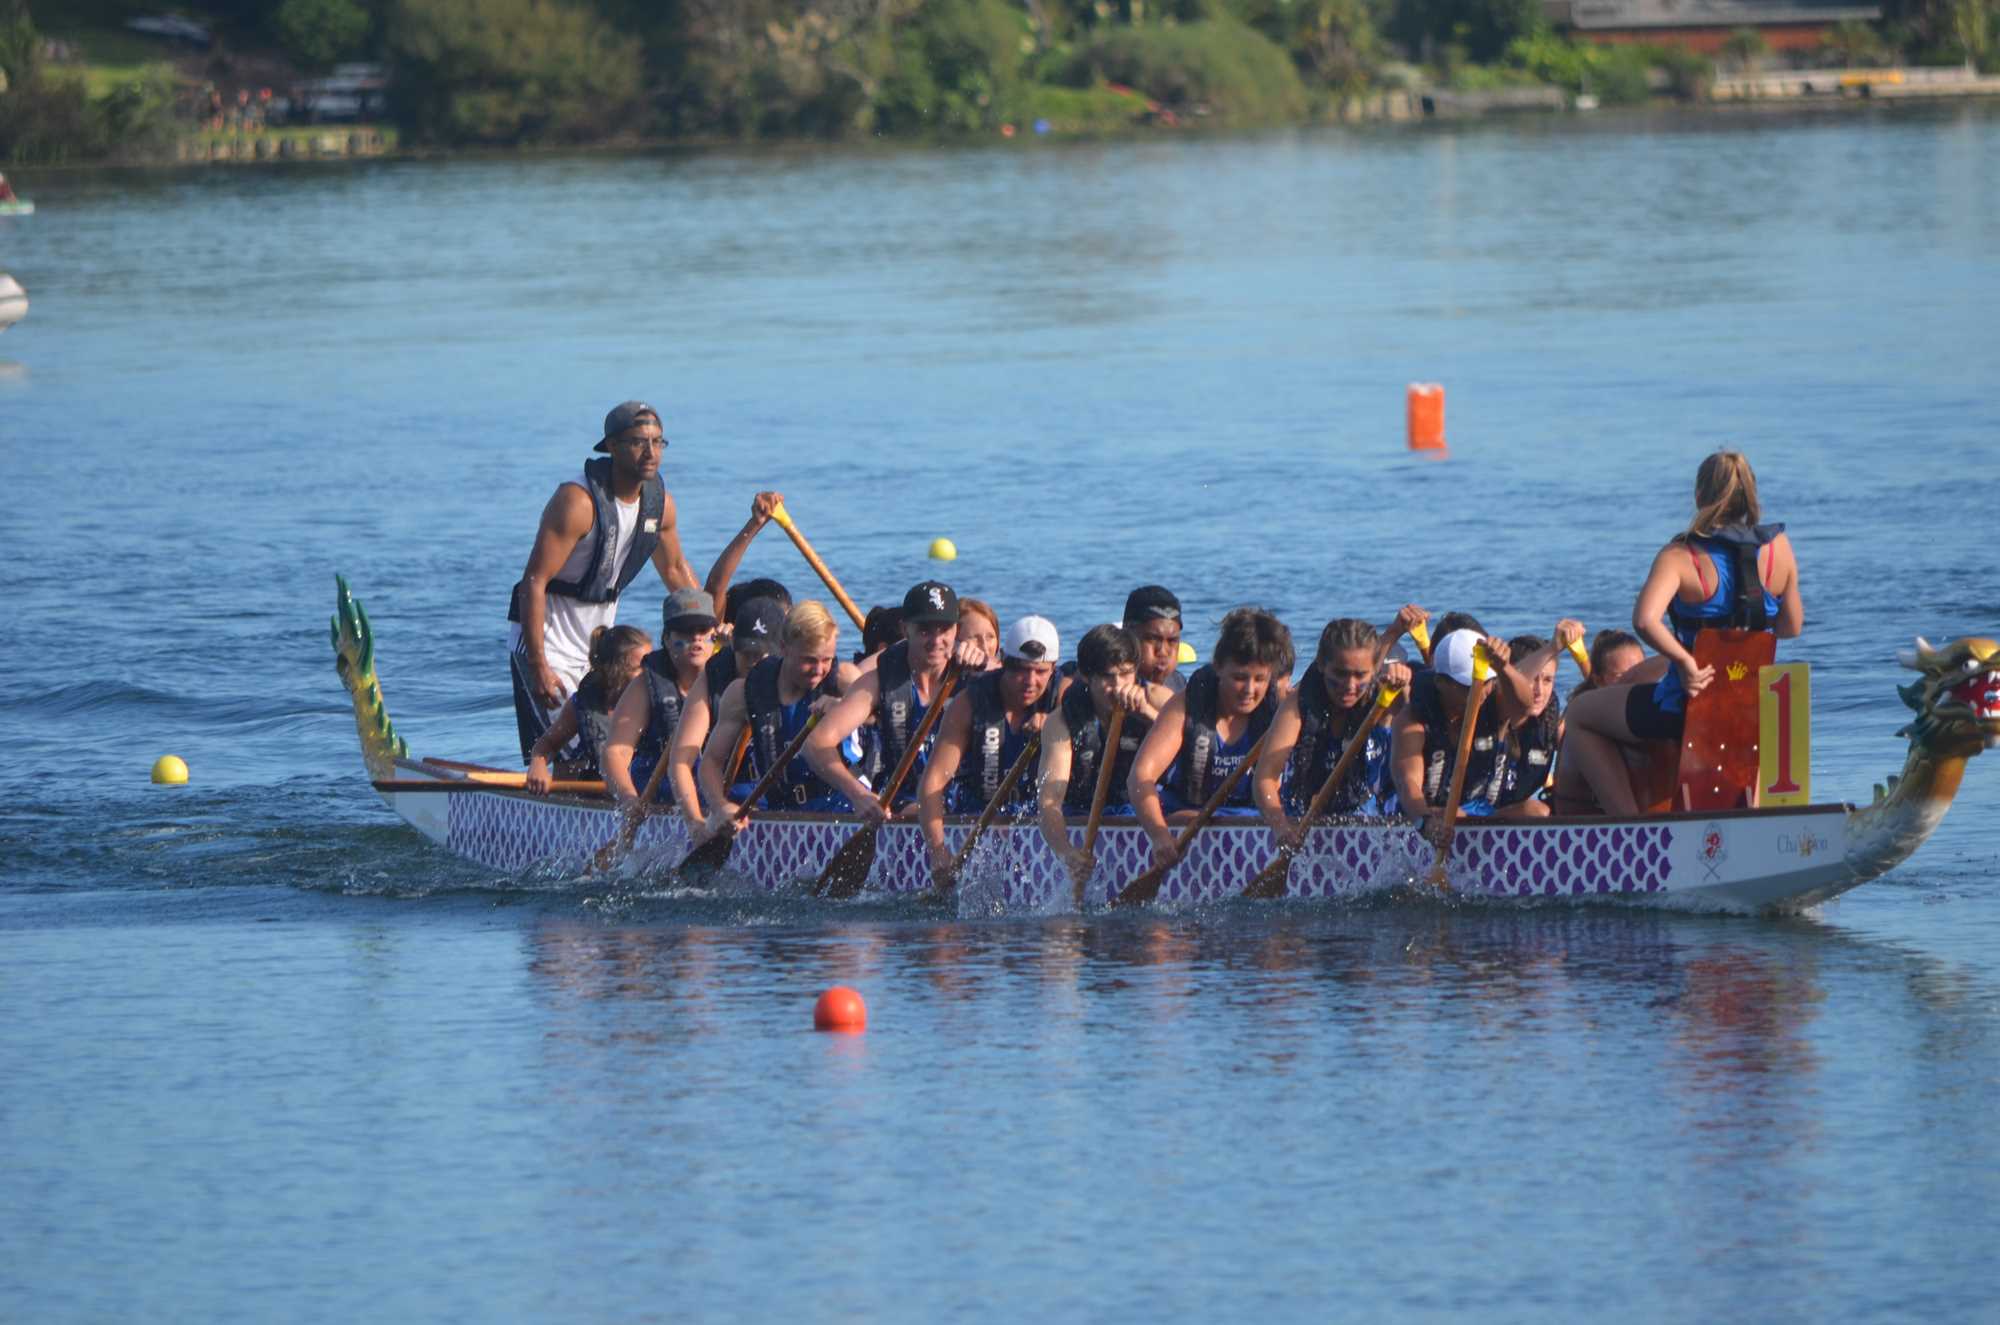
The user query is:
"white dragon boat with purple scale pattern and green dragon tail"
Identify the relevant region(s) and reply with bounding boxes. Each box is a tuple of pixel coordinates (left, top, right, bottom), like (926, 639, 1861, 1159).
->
(332, 576, 2000, 913)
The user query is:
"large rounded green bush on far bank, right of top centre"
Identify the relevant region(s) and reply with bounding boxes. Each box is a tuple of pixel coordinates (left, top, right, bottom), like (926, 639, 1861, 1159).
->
(1062, 16, 1306, 124)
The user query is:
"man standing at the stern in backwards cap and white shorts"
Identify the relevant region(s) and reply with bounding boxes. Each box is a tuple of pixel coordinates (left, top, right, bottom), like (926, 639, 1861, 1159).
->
(506, 400, 700, 761)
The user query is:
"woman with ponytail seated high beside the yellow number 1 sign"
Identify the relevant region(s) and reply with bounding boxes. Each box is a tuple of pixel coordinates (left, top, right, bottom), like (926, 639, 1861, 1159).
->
(1562, 450, 1806, 817)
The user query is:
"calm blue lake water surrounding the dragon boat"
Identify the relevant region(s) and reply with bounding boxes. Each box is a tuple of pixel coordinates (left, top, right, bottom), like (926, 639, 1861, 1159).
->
(0, 108, 2000, 1321)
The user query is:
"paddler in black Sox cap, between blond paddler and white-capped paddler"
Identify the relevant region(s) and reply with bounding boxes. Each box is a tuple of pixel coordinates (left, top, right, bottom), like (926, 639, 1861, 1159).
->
(806, 580, 986, 823)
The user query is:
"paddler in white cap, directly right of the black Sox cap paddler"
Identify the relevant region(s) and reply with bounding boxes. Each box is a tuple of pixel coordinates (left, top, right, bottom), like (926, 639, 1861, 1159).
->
(918, 616, 1062, 883)
